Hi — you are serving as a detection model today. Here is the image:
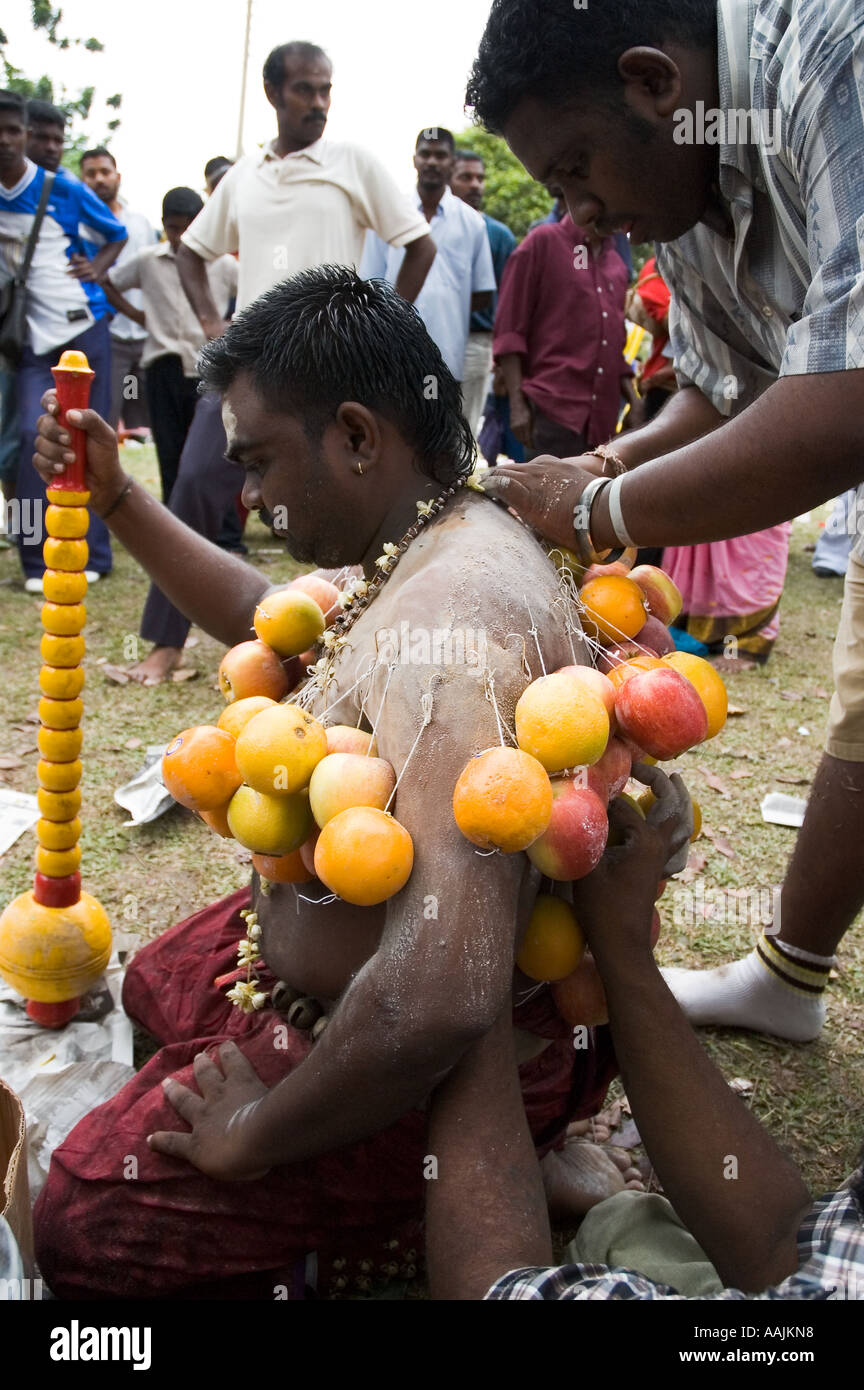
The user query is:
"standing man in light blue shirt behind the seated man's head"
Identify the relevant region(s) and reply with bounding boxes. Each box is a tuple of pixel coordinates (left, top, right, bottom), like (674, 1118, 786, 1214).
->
(360, 125, 496, 382)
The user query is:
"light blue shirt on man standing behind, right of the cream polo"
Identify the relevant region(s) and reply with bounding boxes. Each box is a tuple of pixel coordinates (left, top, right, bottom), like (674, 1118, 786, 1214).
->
(360, 188, 497, 381)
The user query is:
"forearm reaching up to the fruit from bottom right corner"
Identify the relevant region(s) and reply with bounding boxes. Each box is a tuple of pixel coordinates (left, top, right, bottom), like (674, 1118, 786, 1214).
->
(599, 948, 810, 1293)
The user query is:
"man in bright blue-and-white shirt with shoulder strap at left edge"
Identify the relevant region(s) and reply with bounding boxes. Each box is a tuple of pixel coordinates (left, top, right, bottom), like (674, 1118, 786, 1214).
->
(0, 92, 126, 592)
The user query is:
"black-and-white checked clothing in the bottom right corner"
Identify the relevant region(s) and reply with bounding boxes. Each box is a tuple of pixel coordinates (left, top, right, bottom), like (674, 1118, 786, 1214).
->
(486, 1173, 864, 1302)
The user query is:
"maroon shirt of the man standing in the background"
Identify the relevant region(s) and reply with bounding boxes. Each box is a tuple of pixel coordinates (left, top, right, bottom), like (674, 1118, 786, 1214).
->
(493, 217, 632, 459)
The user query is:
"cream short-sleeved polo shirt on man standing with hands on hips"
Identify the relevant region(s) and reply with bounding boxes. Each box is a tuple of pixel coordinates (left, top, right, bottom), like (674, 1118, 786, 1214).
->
(183, 136, 429, 309)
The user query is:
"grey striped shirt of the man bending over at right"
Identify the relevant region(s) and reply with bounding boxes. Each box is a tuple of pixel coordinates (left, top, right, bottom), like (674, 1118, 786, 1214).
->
(657, 0, 864, 559)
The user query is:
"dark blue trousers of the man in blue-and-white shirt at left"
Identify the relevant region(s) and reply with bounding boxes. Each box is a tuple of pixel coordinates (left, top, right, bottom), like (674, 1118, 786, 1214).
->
(18, 318, 111, 580)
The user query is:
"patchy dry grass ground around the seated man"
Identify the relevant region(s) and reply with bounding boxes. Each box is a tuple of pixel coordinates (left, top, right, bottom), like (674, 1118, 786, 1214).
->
(0, 449, 864, 1188)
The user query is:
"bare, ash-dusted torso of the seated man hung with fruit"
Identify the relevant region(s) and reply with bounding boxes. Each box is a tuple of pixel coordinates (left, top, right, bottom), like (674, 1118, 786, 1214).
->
(253, 492, 586, 1001)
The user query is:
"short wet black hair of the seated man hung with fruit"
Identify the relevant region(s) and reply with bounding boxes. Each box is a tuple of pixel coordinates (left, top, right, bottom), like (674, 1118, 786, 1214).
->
(199, 265, 474, 487)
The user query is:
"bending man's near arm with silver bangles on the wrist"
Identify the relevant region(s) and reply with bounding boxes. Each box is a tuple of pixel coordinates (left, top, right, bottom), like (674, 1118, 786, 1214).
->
(483, 370, 864, 549)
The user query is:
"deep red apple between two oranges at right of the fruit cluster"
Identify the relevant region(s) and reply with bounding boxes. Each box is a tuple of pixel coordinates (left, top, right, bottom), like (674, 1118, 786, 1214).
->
(615, 670, 708, 762)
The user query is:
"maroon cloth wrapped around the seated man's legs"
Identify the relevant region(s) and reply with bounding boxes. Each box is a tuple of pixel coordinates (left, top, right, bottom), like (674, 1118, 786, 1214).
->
(33, 890, 617, 1298)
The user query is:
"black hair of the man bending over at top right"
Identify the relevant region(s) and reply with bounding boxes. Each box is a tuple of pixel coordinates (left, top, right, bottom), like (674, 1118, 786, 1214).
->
(465, 0, 717, 133)
